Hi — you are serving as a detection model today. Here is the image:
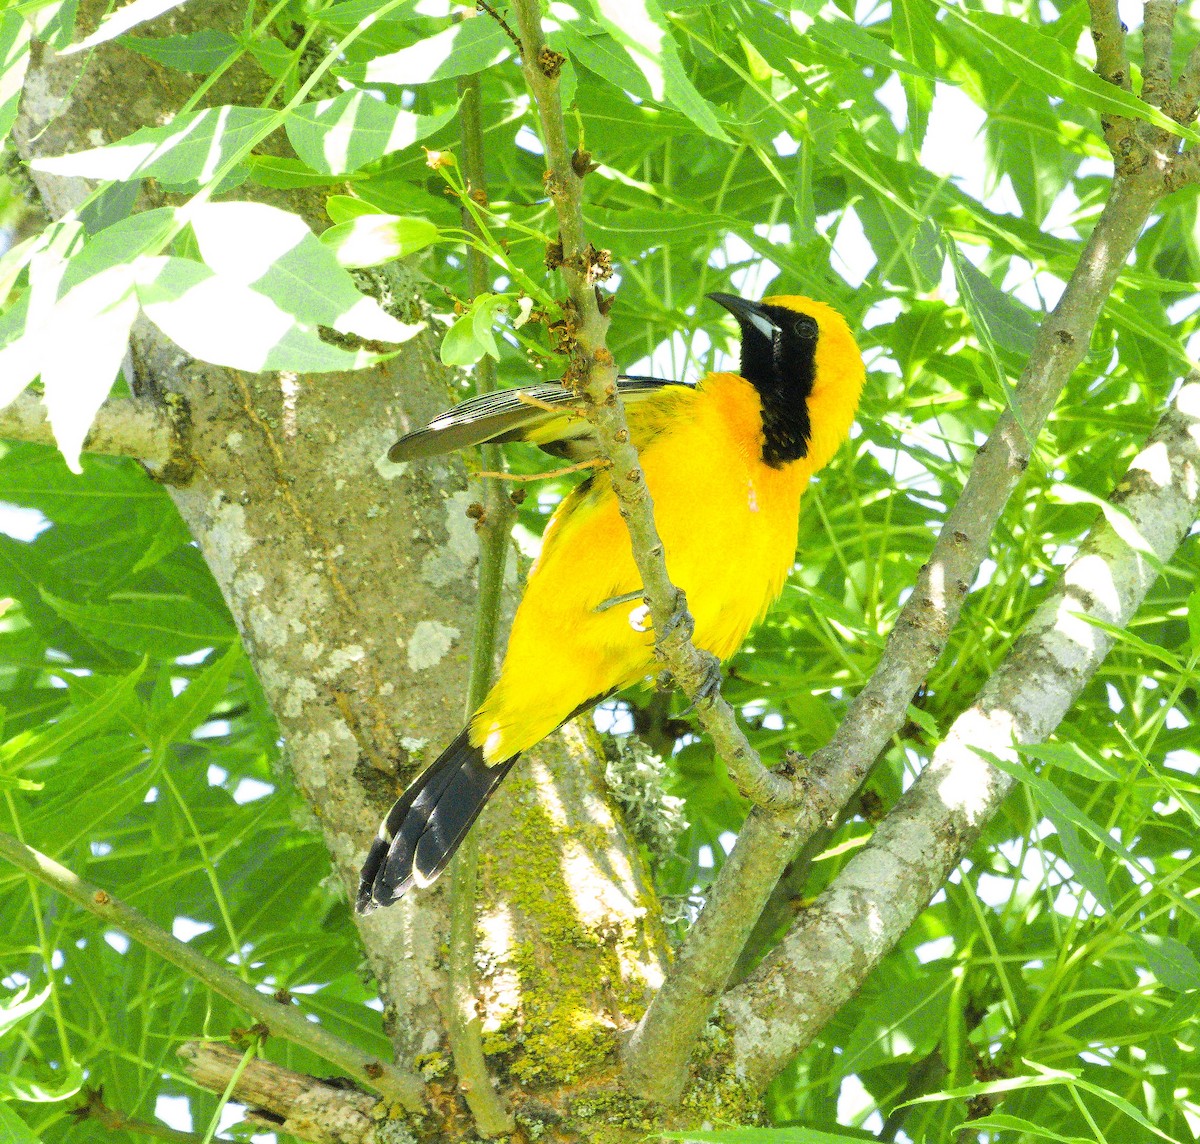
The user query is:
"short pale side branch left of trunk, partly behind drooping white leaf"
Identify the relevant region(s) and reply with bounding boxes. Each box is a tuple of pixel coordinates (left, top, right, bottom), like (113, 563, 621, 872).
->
(0, 389, 191, 470)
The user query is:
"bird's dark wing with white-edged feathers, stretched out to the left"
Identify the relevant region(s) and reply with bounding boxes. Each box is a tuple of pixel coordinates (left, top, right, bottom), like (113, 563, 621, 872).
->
(388, 376, 691, 461)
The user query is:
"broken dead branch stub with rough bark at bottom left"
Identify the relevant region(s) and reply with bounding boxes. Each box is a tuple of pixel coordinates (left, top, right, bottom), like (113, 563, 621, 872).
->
(179, 1041, 383, 1144)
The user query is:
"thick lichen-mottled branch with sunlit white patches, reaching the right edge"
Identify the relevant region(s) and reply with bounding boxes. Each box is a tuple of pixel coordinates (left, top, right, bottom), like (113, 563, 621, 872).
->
(721, 375, 1200, 1085)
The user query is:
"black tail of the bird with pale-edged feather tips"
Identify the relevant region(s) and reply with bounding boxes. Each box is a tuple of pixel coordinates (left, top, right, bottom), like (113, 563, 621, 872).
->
(355, 731, 517, 914)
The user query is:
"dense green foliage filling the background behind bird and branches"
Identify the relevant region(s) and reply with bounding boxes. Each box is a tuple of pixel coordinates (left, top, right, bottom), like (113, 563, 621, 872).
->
(0, 0, 1200, 1144)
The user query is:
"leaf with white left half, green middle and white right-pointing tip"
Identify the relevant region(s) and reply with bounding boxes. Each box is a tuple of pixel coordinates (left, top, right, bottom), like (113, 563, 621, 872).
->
(191, 203, 422, 343)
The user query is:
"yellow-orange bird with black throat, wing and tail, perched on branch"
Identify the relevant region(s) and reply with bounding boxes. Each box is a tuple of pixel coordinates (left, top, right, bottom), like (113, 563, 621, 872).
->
(355, 293, 865, 914)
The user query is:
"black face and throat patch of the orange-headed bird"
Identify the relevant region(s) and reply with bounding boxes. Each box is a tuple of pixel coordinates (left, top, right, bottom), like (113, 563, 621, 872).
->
(739, 306, 817, 468)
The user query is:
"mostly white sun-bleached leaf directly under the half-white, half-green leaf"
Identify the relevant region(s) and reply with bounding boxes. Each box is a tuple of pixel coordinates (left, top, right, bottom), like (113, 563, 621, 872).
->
(136, 257, 379, 373)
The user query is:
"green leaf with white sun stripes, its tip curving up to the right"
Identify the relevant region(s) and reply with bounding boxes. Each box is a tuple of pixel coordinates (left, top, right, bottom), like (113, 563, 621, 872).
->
(284, 91, 458, 174)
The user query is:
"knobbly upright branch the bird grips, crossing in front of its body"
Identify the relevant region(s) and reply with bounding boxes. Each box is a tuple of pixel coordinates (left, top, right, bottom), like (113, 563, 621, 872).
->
(504, 0, 800, 807)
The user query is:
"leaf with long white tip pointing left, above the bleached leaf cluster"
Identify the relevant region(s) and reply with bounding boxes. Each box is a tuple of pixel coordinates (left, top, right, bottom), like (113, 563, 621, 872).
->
(30, 106, 275, 190)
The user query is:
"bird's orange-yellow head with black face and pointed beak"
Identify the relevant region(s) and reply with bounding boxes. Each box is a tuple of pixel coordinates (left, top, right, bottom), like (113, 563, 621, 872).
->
(708, 294, 865, 471)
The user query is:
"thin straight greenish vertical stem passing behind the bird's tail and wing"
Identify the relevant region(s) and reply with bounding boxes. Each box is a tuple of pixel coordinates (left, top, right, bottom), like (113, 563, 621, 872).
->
(446, 64, 515, 1137)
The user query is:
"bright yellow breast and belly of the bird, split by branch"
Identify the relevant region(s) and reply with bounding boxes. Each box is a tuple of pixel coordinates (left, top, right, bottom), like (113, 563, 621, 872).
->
(470, 373, 811, 762)
